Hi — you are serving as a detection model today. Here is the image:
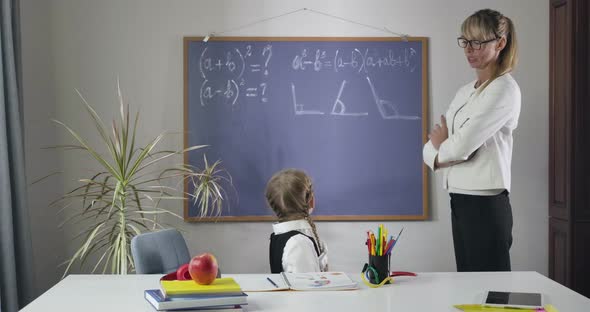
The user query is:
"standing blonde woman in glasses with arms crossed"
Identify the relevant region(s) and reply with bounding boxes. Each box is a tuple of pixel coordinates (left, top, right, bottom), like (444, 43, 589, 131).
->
(423, 9, 521, 271)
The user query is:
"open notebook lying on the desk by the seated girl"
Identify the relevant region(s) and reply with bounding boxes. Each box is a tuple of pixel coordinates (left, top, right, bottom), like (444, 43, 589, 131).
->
(238, 272, 358, 291)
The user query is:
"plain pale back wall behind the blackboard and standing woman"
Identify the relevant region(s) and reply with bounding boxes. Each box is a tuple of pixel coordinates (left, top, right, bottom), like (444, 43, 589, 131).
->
(23, 0, 549, 296)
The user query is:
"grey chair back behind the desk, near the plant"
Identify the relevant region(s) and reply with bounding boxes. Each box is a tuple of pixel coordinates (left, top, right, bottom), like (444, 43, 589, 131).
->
(131, 229, 191, 274)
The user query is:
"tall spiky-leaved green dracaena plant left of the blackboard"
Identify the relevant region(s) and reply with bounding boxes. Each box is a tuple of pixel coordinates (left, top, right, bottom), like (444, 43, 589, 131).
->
(43, 83, 231, 277)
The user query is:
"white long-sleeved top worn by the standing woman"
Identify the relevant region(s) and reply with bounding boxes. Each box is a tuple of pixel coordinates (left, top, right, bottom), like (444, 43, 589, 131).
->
(422, 74, 521, 195)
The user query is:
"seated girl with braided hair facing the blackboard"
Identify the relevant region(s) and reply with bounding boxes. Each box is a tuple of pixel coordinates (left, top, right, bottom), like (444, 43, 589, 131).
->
(266, 169, 328, 273)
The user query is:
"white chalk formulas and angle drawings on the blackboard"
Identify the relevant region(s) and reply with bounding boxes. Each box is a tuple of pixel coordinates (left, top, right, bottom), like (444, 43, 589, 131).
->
(199, 44, 420, 120)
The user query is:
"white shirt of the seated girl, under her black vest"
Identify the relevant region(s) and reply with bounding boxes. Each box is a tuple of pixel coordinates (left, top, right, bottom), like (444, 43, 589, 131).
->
(272, 220, 328, 273)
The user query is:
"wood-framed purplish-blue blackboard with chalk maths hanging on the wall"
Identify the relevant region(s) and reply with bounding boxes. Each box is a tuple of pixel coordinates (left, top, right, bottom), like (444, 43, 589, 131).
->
(184, 37, 428, 221)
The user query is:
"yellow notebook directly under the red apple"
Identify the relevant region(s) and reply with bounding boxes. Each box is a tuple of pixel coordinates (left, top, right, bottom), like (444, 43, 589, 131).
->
(160, 277, 242, 296)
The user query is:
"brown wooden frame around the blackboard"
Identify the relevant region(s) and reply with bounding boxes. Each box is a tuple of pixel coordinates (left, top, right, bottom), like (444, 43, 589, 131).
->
(183, 37, 429, 222)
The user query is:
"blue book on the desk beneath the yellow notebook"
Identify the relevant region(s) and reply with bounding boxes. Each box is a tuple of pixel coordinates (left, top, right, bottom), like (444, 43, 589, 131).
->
(144, 289, 248, 312)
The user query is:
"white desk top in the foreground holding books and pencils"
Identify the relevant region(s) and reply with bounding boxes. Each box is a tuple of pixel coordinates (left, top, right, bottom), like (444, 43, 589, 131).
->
(21, 272, 590, 312)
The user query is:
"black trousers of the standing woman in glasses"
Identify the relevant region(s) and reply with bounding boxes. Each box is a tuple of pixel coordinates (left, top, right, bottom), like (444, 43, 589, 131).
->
(451, 191, 512, 272)
